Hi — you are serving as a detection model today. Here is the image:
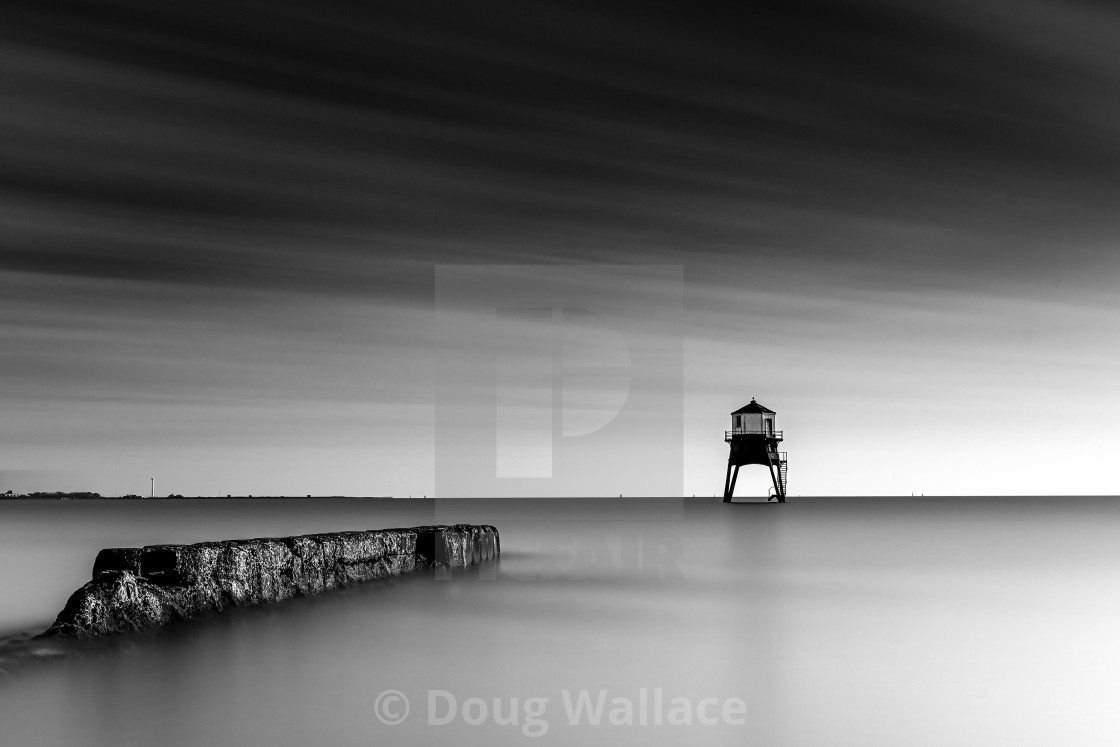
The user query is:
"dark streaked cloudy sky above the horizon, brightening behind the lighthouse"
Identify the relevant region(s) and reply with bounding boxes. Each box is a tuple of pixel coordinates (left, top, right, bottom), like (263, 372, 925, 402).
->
(0, 0, 1120, 496)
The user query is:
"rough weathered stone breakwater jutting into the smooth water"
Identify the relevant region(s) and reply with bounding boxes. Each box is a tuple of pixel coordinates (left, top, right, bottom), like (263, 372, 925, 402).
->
(44, 524, 501, 638)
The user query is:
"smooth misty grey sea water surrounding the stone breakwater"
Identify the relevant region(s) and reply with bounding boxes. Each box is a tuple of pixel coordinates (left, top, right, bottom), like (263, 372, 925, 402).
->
(0, 497, 1120, 747)
